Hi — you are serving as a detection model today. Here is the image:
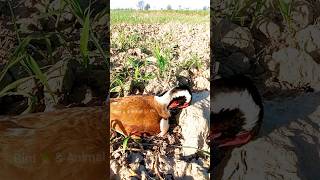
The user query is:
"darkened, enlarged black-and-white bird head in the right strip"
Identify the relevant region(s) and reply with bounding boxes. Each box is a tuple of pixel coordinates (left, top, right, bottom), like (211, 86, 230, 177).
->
(208, 75, 263, 147)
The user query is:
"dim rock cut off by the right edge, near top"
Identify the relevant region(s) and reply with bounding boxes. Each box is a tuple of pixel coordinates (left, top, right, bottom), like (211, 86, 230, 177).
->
(296, 25, 320, 64)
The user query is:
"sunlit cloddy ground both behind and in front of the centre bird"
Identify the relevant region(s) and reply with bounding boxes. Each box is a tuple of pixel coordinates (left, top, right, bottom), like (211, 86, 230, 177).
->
(110, 10, 210, 179)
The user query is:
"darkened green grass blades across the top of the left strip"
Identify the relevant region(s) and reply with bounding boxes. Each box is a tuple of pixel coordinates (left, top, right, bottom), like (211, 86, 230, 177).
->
(0, 0, 109, 114)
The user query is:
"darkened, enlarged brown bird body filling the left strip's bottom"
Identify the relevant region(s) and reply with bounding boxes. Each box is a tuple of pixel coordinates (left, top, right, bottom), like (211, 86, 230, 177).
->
(0, 107, 109, 180)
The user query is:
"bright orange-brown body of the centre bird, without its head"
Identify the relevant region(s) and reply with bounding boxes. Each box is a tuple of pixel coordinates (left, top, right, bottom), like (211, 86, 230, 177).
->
(110, 96, 170, 136)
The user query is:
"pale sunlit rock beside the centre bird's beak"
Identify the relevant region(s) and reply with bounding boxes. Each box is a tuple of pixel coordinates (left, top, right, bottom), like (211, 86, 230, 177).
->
(178, 91, 210, 156)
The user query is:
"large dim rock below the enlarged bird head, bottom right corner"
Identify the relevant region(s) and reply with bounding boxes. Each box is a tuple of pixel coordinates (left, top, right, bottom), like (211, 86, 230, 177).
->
(220, 93, 320, 180)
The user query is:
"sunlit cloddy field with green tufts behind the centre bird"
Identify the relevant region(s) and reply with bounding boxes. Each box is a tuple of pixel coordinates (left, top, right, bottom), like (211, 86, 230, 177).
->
(110, 10, 210, 97)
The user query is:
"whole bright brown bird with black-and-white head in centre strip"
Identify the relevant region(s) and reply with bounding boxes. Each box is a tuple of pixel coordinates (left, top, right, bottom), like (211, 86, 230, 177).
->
(110, 86, 192, 138)
